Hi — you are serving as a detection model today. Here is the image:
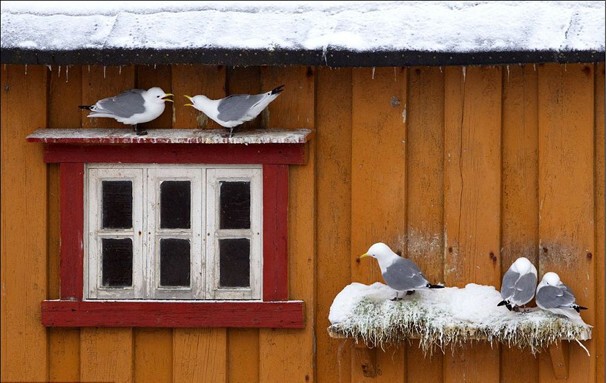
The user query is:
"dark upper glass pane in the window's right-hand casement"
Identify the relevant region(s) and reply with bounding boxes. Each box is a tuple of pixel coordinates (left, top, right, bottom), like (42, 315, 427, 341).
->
(219, 182, 251, 229)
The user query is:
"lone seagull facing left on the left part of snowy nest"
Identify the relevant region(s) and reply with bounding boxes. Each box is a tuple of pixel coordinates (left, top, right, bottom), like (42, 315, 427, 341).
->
(359, 242, 444, 300)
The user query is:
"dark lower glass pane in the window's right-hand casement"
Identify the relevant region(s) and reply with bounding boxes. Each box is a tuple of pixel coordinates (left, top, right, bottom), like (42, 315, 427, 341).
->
(219, 238, 251, 287)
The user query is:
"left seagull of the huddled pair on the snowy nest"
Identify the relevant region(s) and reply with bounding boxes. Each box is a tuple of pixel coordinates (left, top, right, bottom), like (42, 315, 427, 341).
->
(497, 257, 537, 311)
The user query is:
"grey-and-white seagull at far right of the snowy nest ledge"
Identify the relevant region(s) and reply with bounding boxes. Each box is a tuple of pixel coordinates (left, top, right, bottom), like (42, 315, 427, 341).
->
(535, 271, 588, 320)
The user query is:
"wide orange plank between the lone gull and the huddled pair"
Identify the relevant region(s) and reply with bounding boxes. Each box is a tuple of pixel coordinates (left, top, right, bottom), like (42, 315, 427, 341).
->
(444, 67, 502, 382)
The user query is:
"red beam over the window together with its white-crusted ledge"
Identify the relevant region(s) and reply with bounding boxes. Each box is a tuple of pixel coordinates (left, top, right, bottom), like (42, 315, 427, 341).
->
(27, 129, 314, 165)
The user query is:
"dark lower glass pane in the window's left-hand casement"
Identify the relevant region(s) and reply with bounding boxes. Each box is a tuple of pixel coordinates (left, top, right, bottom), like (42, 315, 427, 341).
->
(101, 238, 133, 287)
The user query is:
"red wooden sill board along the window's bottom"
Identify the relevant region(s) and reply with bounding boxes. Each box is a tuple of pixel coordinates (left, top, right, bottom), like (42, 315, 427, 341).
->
(42, 300, 304, 328)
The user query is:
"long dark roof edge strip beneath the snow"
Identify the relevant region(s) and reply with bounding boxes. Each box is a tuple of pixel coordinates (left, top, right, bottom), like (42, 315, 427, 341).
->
(0, 48, 605, 67)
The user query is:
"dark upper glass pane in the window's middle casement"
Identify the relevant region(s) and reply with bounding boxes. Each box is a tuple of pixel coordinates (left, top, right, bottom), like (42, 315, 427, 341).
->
(160, 181, 190, 229)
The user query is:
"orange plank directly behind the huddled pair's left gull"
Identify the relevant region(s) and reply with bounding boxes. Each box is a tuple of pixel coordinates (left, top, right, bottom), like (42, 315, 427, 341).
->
(496, 65, 539, 383)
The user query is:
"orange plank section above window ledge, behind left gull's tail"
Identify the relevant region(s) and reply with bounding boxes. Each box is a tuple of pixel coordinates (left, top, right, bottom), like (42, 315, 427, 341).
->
(81, 65, 135, 131)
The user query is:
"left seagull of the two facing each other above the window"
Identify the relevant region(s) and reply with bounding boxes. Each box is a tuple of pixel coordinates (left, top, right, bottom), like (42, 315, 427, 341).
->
(79, 87, 173, 136)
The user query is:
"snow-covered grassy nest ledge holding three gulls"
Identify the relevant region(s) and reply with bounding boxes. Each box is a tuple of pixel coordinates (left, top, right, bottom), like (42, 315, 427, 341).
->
(328, 282, 592, 354)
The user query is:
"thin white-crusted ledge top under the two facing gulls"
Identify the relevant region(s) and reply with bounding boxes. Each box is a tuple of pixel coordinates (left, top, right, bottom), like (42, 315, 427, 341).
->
(27, 128, 312, 145)
